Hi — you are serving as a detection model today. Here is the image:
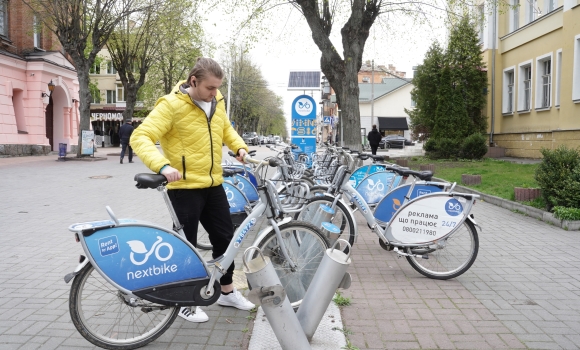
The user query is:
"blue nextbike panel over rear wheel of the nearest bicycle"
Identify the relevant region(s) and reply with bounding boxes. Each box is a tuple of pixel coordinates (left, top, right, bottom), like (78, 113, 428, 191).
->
(84, 226, 208, 290)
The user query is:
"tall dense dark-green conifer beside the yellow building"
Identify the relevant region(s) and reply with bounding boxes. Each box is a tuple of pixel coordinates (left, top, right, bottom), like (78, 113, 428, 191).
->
(407, 16, 487, 159)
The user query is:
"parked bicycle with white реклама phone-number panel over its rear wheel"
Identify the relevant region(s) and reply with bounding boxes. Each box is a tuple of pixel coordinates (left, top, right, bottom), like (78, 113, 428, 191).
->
(296, 155, 479, 279)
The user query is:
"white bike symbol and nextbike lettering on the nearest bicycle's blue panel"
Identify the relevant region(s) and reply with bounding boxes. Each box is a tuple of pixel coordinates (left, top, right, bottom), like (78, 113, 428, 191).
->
(127, 236, 177, 280)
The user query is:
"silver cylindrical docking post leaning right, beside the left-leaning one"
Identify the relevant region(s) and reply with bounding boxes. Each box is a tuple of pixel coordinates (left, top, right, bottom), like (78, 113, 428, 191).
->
(296, 239, 352, 340)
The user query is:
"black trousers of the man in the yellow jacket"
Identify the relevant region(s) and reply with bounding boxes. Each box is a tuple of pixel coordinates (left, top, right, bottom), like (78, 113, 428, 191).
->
(167, 185, 235, 285)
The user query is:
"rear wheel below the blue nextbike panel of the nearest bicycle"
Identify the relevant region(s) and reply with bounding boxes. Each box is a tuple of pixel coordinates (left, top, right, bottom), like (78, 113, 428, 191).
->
(69, 263, 179, 350)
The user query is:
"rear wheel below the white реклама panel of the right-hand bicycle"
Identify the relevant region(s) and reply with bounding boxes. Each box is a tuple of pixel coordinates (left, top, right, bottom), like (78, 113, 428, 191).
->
(405, 220, 479, 280)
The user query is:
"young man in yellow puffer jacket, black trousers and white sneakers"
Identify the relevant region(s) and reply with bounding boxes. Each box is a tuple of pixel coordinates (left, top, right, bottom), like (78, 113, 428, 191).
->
(131, 58, 254, 322)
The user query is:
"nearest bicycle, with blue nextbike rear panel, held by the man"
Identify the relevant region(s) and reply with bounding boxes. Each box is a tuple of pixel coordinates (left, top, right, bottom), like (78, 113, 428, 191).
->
(64, 156, 328, 349)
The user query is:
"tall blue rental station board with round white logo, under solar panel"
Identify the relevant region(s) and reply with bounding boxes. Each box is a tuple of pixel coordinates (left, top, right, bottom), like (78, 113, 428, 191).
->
(291, 95, 316, 168)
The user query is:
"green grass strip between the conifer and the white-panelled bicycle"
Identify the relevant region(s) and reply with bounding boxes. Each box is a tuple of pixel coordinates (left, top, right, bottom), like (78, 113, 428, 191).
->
(409, 157, 543, 201)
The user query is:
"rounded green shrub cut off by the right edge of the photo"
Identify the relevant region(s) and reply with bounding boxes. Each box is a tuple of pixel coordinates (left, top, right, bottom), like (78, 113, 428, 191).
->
(534, 146, 580, 209)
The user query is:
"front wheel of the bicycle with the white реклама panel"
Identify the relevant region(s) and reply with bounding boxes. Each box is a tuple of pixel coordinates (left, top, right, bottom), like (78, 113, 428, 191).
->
(295, 194, 356, 247)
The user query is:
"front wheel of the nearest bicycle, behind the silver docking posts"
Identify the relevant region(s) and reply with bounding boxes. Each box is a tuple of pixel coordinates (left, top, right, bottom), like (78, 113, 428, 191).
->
(252, 221, 328, 307)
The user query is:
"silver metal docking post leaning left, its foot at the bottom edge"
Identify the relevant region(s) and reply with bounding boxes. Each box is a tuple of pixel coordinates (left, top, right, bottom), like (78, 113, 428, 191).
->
(242, 246, 310, 350)
